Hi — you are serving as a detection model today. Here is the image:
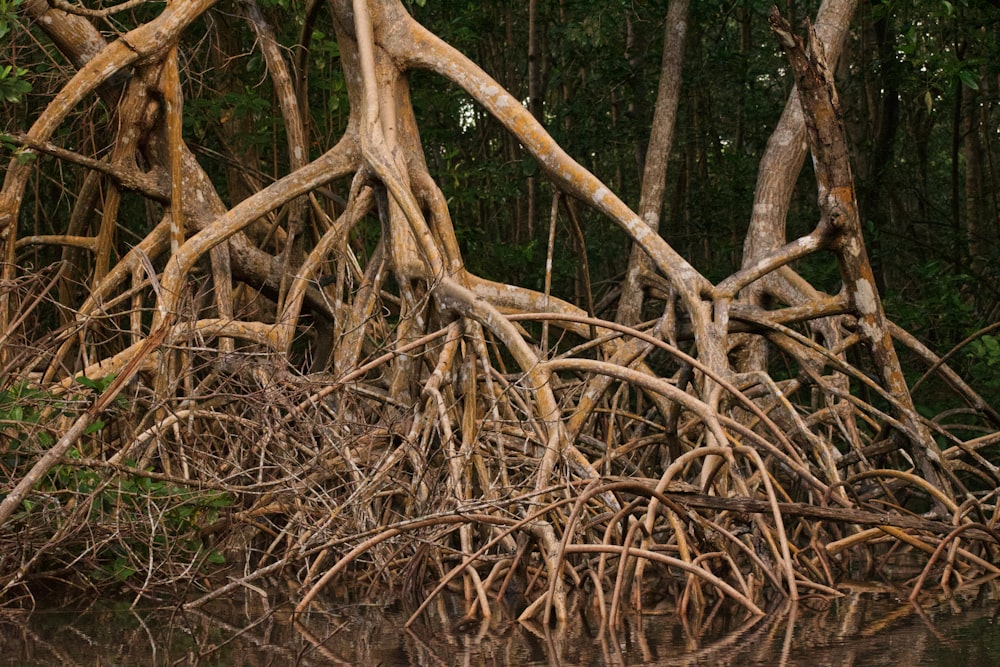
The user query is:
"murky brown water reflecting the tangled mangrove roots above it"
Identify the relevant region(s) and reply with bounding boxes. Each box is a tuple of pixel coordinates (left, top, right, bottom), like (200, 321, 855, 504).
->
(0, 588, 1000, 667)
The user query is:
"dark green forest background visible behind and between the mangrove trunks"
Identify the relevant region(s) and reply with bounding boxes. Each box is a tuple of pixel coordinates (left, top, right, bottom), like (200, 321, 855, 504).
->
(7, 0, 1000, 380)
